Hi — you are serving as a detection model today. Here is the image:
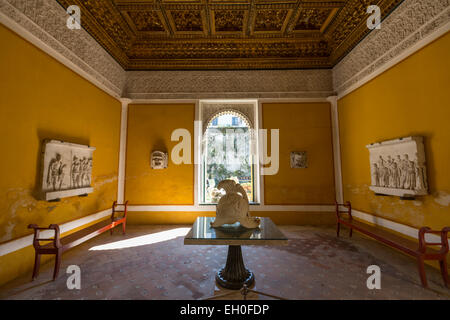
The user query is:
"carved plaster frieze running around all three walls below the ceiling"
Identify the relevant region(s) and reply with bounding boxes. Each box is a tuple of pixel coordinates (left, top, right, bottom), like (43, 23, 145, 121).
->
(0, 0, 450, 100)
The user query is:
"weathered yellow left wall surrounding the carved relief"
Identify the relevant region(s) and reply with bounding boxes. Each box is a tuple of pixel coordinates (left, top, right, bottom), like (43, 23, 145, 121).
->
(0, 25, 121, 284)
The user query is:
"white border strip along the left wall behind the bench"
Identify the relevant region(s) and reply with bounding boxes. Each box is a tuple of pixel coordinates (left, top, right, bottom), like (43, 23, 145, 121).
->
(0, 209, 111, 257)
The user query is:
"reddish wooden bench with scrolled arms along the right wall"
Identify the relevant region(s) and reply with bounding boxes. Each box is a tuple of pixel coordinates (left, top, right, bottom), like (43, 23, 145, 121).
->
(336, 202, 450, 288)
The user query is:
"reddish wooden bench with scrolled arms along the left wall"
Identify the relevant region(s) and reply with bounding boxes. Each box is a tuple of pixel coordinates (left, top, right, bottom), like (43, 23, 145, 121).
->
(28, 201, 128, 280)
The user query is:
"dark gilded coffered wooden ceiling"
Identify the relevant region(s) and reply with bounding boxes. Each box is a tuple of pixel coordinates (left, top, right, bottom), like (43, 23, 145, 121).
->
(58, 0, 403, 70)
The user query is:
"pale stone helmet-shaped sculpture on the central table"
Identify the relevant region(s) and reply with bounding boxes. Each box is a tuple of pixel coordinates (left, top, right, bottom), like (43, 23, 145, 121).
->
(211, 180, 260, 229)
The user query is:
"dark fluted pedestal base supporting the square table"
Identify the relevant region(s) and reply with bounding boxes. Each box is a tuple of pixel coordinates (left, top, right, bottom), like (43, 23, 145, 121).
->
(216, 246, 255, 290)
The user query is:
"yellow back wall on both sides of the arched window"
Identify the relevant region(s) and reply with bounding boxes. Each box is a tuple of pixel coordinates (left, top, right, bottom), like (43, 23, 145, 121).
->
(125, 103, 334, 224)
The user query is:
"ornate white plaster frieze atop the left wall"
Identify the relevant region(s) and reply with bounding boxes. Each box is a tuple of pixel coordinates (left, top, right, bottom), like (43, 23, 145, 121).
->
(0, 0, 125, 97)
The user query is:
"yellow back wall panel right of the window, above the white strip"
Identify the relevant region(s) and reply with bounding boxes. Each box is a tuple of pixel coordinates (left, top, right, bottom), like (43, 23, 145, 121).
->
(263, 103, 335, 205)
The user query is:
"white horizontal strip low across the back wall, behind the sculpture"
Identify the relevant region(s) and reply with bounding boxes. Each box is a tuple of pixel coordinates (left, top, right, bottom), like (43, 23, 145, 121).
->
(128, 205, 334, 213)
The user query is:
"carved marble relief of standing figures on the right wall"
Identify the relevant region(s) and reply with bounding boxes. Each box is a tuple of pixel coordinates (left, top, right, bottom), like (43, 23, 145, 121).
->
(366, 137, 428, 197)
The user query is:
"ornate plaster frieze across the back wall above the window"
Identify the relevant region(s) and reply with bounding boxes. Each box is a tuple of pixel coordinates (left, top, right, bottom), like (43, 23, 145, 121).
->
(124, 70, 333, 99)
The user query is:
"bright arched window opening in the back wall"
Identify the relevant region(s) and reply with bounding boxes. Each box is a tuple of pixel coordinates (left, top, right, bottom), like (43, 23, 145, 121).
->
(201, 110, 255, 203)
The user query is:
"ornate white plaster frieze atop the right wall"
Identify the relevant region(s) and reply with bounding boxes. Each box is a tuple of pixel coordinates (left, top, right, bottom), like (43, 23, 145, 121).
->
(333, 0, 450, 96)
